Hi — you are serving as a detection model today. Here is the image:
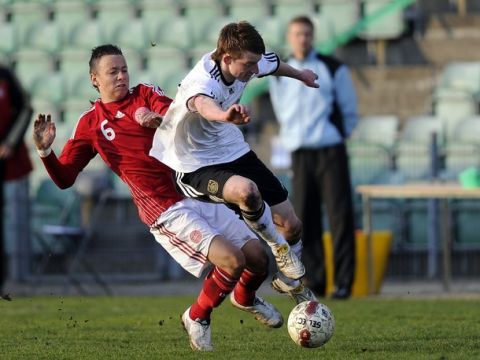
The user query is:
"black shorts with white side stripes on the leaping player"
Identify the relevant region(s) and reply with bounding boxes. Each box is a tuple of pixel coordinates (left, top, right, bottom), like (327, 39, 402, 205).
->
(175, 151, 288, 206)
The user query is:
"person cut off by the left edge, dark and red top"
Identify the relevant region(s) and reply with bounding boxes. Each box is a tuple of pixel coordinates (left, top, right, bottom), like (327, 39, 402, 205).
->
(0, 65, 32, 292)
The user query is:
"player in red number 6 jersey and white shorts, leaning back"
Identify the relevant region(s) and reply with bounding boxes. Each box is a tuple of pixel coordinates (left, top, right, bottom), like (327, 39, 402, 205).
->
(33, 45, 283, 351)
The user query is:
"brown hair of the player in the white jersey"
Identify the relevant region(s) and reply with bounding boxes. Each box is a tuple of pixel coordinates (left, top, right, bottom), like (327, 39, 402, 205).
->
(212, 21, 265, 61)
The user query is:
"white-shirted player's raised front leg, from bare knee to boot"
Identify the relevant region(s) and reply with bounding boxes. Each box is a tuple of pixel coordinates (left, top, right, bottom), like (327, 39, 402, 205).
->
(223, 175, 305, 279)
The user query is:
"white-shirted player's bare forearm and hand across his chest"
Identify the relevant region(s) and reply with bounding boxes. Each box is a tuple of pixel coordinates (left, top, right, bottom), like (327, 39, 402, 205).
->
(188, 95, 250, 125)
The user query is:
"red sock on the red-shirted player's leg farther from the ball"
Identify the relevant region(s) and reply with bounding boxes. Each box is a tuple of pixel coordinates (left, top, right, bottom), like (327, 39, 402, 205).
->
(190, 267, 238, 320)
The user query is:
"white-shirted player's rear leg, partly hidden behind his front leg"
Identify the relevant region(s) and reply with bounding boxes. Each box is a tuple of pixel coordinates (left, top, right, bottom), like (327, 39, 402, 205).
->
(271, 199, 318, 304)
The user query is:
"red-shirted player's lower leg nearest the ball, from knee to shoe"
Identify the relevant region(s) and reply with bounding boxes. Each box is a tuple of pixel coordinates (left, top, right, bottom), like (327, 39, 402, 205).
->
(230, 240, 283, 328)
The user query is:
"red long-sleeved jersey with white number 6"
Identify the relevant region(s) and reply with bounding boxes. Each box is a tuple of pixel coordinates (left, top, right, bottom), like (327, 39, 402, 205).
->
(42, 84, 183, 225)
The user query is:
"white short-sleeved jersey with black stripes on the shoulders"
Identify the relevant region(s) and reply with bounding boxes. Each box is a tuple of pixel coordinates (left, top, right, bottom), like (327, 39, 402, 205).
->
(150, 53, 280, 173)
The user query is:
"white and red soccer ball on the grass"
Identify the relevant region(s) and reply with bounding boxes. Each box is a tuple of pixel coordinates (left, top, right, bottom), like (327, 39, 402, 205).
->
(288, 301, 335, 348)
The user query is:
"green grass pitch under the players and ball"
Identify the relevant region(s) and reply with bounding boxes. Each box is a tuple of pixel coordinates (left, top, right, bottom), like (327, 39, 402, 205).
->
(0, 296, 480, 360)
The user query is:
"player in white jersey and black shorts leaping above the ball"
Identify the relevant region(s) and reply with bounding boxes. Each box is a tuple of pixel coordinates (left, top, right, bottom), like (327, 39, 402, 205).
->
(150, 21, 318, 303)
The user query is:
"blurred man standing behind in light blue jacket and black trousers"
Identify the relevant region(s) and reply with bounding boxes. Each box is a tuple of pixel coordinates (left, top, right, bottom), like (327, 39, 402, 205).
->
(270, 16, 358, 299)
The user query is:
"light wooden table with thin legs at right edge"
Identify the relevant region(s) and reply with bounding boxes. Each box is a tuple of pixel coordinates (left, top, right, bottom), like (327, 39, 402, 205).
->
(356, 182, 480, 294)
